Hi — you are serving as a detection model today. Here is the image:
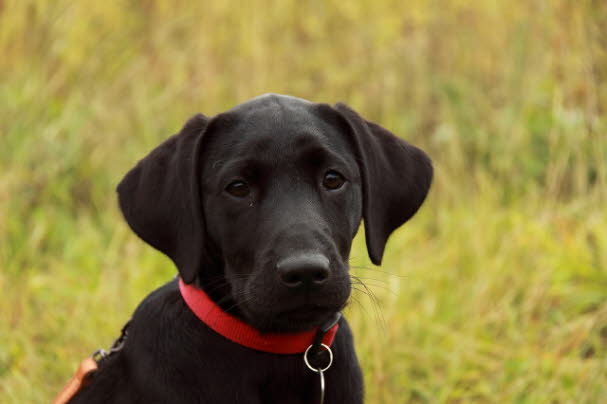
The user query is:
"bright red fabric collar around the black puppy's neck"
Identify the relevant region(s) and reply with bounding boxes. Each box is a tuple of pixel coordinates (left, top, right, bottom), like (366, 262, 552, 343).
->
(179, 278, 339, 354)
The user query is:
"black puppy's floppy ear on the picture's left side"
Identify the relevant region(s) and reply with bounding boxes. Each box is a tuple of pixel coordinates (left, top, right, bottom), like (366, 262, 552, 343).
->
(117, 114, 209, 283)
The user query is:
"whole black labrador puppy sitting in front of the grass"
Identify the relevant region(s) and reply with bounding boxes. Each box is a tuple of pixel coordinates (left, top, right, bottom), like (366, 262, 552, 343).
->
(71, 94, 432, 404)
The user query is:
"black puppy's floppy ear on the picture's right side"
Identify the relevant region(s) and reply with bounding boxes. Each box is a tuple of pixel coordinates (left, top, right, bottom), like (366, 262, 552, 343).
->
(335, 103, 433, 265)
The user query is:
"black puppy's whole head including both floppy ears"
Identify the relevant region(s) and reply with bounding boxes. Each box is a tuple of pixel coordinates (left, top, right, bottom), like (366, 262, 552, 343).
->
(118, 95, 432, 332)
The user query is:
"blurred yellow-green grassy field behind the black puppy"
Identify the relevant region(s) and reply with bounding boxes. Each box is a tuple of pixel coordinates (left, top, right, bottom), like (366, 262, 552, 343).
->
(0, 0, 607, 404)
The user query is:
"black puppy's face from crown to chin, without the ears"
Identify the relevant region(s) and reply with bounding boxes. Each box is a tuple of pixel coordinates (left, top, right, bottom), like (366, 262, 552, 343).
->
(200, 97, 362, 330)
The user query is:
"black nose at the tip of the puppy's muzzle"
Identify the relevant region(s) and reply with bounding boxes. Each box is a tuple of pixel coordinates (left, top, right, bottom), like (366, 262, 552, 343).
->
(276, 254, 329, 289)
